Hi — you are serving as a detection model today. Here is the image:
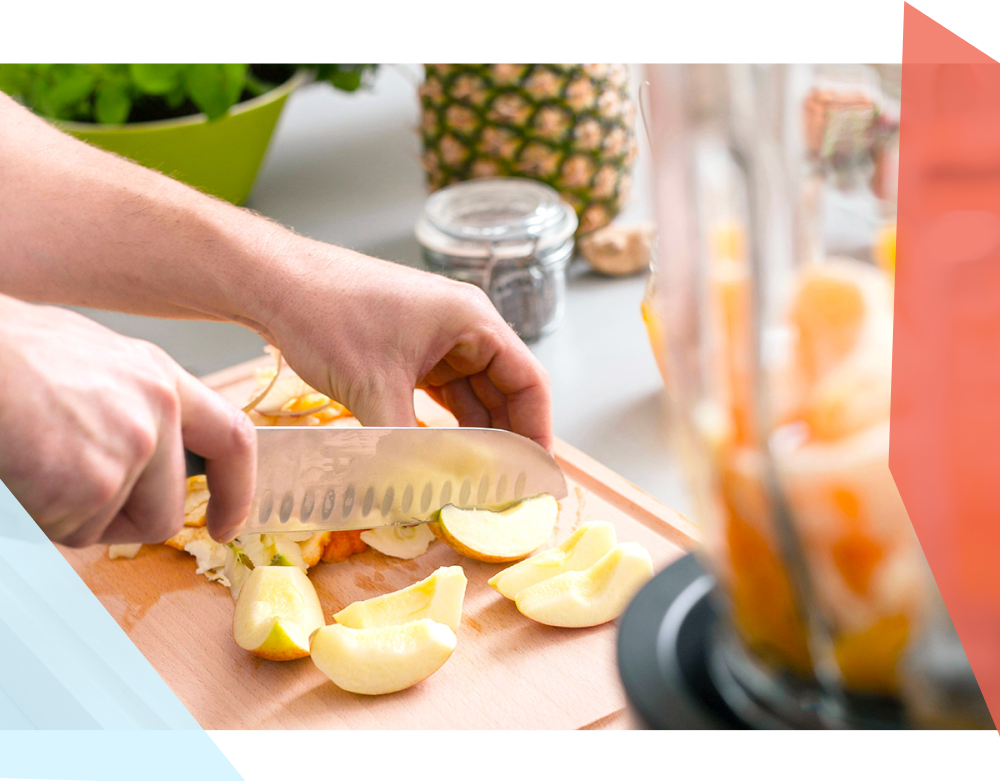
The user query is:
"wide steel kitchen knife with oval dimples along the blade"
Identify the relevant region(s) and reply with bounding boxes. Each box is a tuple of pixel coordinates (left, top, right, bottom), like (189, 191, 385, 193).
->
(184, 426, 567, 534)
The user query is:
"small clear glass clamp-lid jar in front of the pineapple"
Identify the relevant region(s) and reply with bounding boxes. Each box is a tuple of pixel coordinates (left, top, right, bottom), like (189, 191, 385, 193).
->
(416, 177, 578, 342)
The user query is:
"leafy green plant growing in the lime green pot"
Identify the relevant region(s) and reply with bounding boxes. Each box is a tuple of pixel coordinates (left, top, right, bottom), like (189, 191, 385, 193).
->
(0, 62, 378, 125)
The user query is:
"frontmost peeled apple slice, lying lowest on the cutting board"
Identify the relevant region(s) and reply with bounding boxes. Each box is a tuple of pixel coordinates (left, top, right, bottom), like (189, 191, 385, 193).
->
(310, 618, 457, 694)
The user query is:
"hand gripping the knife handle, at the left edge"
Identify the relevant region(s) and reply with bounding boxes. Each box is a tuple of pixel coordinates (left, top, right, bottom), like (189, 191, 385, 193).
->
(0, 296, 256, 547)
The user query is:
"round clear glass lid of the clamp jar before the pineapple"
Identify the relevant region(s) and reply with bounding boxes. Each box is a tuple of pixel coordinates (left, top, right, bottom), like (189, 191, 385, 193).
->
(417, 177, 578, 260)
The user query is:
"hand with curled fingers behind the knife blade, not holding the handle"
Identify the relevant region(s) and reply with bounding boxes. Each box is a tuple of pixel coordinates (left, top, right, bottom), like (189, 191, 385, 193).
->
(259, 241, 554, 452)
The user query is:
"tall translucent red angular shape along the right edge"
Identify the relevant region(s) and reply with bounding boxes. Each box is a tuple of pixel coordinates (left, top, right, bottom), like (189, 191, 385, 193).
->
(889, 4, 1000, 723)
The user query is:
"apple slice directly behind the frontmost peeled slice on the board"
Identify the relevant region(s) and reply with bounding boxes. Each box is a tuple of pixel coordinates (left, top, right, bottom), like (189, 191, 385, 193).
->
(333, 567, 468, 632)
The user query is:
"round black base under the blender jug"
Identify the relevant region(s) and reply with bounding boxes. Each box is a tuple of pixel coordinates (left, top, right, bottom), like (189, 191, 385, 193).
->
(618, 555, 909, 730)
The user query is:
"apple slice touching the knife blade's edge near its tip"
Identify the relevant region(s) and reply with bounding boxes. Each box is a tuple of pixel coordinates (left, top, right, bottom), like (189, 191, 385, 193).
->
(430, 494, 559, 563)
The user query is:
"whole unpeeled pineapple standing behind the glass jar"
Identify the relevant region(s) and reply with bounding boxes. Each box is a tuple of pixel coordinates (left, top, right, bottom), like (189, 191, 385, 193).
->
(420, 62, 637, 235)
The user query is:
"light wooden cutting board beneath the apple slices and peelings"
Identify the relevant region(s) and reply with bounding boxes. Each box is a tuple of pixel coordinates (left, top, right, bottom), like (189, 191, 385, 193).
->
(54, 358, 698, 730)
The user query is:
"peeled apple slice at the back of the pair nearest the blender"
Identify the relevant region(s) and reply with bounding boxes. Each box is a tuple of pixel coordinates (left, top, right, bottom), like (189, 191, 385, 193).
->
(489, 521, 618, 599)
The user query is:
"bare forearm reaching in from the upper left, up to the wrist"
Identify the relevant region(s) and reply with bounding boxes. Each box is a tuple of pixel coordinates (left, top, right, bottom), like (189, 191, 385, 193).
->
(0, 94, 297, 331)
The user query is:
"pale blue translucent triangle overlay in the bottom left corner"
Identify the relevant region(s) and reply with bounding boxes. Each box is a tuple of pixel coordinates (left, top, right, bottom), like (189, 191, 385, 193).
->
(0, 482, 240, 779)
